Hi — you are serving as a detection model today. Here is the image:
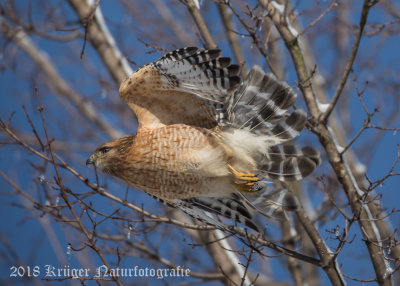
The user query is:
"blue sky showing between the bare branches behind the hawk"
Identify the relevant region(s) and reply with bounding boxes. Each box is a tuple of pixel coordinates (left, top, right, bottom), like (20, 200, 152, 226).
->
(0, 0, 400, 285)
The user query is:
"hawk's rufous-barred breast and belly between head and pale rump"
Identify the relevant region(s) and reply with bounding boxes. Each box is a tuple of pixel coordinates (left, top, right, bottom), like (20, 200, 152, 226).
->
(123, 124, 230, 199)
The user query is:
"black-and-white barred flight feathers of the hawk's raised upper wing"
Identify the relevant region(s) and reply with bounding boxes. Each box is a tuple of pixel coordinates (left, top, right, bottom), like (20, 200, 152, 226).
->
(151, 47, 242, 125)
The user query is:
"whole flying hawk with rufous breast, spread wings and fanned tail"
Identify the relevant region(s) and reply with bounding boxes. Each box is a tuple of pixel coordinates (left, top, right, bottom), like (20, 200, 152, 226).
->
(86, 47, 320, 230)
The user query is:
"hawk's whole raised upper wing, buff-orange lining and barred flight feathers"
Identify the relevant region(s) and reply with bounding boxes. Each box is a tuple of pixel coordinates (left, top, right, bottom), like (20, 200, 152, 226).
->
(119, 47, 241, 128)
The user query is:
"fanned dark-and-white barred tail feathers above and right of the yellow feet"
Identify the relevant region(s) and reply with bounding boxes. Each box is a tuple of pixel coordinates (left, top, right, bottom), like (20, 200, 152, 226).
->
(223, 66, 320, 182)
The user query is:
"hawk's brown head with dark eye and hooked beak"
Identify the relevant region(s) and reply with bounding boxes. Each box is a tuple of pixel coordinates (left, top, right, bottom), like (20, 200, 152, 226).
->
(86, 135, 135, 173)
